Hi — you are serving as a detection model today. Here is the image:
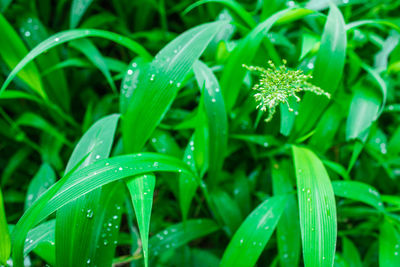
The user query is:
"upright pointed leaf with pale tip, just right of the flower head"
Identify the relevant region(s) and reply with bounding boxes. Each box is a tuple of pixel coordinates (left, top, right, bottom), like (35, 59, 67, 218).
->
(295, 4, 347, 136)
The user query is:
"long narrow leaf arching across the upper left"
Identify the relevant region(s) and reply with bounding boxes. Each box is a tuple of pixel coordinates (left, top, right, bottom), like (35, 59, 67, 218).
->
(0, 29, 151, 94)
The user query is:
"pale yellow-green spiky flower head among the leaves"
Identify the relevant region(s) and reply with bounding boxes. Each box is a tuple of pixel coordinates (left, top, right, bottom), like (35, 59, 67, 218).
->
(243, 60, 330, 122)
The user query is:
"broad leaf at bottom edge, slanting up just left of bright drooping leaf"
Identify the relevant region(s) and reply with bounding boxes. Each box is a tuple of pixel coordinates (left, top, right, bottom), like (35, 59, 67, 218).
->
(220, 196, 287, 267)
